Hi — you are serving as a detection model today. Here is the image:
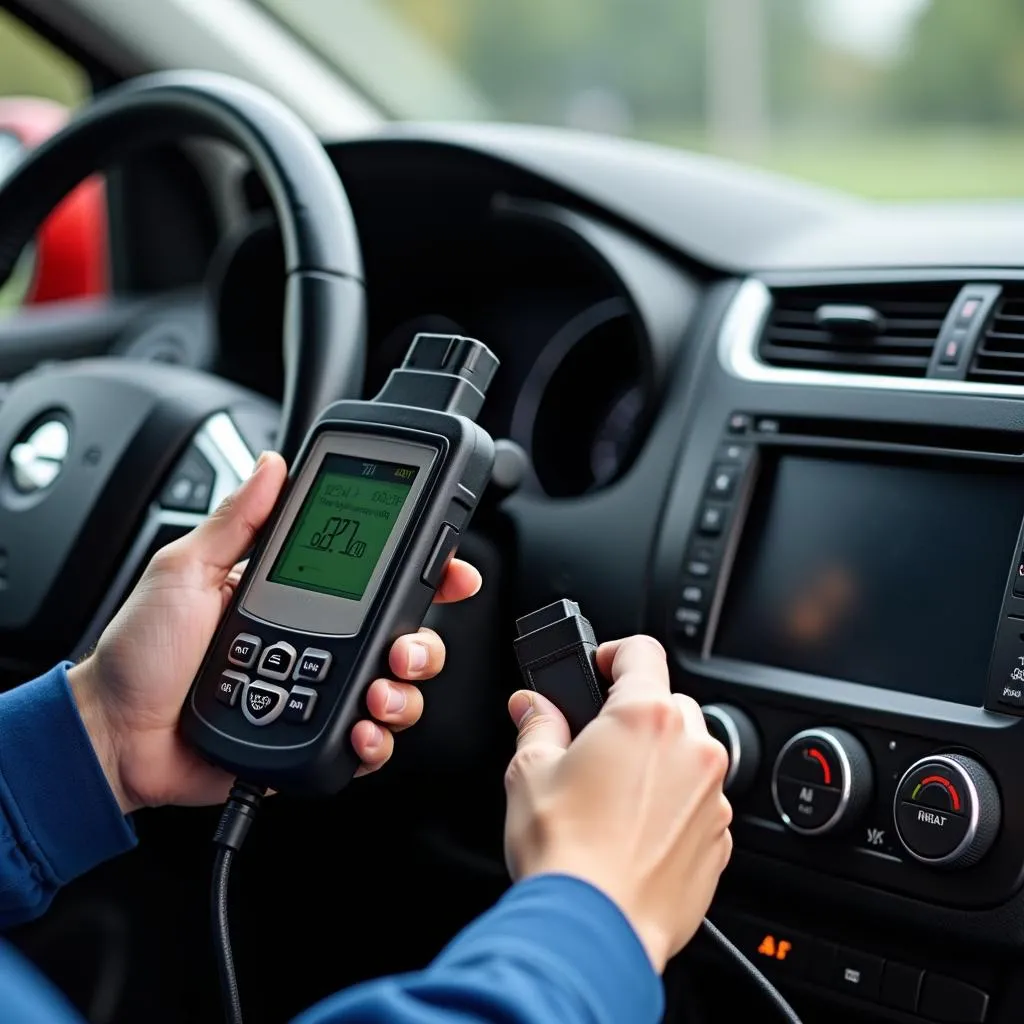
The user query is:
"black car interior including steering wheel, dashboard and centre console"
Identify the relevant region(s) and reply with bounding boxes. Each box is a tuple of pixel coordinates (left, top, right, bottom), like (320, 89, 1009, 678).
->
(0, 4, 1024, 1024)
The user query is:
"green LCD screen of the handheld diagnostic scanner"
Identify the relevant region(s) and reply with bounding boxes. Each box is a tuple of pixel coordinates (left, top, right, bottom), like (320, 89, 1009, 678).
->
(267, 455, 419, 601)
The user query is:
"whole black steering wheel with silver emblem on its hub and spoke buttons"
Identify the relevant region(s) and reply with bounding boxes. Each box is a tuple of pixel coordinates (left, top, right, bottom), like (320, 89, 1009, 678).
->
(0, 72, 366, 678)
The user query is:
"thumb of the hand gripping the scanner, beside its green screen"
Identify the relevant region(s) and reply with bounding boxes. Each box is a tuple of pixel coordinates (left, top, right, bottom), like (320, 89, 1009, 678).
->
(183, 452, 288, 572)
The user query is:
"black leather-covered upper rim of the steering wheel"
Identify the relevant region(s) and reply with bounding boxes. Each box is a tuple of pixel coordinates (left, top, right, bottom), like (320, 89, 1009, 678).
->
(0, 72, 366, 457)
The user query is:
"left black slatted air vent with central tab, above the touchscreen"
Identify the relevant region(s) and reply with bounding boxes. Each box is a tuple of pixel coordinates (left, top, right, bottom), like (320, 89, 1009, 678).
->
(759, 283, 958, 377)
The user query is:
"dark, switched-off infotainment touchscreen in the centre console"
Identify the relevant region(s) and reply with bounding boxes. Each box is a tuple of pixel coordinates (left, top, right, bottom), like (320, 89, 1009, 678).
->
(714, 454, 1024, 706)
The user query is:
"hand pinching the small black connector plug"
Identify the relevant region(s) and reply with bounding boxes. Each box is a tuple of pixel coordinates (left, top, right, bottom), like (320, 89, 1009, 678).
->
(505, 637, 732, 973)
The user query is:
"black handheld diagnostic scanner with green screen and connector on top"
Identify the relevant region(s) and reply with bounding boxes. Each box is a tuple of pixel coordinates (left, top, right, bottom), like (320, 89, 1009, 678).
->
(181, 334, 498, 795)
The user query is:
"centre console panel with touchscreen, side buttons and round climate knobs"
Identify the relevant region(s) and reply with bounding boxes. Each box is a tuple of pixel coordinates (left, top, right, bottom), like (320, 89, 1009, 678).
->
(656, 274, 1024, 929)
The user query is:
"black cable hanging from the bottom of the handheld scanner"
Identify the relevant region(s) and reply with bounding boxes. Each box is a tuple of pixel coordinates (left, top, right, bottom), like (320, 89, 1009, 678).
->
(210, 781, 266, 1024)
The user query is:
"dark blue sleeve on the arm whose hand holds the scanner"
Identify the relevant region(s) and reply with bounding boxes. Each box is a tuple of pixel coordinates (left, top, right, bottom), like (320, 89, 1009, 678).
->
(0, 664, 135, 928)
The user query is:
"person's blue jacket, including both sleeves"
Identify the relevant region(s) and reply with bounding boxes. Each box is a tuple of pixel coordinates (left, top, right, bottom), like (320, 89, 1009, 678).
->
(0, 666, 663, 1024)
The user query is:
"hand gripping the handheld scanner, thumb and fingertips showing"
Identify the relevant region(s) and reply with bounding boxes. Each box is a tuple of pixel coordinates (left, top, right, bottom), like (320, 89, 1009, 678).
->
(68, 453, 481, 814)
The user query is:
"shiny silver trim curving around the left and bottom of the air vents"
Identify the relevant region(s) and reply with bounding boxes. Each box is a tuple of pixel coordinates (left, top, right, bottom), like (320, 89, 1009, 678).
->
(718, 273, 1024, 398)
